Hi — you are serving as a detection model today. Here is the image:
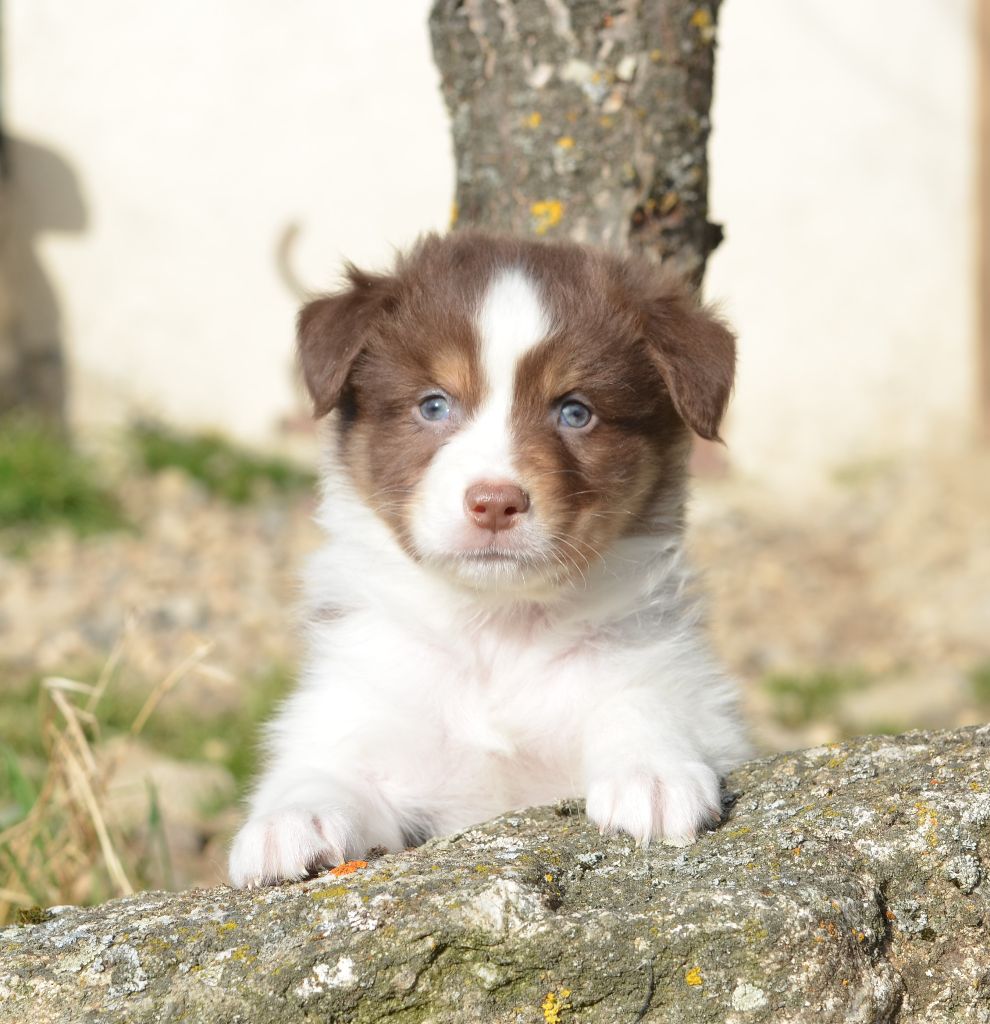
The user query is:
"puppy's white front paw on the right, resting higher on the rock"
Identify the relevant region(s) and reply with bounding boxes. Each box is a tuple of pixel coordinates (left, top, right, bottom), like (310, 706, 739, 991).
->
(588, 761, 722, 846)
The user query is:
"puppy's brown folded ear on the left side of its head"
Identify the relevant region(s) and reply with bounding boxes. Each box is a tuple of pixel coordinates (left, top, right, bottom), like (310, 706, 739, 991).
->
(296, 263, 395, 417)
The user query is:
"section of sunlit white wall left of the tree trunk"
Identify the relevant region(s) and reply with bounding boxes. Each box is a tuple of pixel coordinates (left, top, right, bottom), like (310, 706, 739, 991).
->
(4, 0, 453, 439)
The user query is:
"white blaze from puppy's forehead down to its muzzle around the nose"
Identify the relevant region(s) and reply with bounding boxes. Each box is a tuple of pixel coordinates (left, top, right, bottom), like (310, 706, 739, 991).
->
(411, 267, 552, 554)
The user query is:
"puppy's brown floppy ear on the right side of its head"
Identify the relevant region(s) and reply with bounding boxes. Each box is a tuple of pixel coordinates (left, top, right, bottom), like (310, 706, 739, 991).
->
(645, 279, 736, 440)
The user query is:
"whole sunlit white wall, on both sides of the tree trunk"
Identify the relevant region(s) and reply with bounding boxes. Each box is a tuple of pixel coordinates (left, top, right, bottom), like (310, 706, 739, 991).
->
(4, 0, 975, 483)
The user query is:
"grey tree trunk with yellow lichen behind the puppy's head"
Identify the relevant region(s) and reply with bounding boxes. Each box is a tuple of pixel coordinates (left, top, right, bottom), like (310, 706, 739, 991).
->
(430, 0, 721, 283)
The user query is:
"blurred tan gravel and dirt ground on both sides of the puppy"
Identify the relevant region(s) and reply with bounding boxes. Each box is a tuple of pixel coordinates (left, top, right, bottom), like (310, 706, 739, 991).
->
(0, 446, 990, 884)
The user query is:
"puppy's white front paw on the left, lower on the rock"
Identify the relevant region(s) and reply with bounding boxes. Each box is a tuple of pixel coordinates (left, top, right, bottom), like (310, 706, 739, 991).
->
(229, 807, 352, 888)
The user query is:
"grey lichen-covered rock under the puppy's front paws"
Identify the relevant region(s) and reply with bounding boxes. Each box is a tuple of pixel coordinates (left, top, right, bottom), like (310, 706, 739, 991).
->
(0, 726, 990, 1024)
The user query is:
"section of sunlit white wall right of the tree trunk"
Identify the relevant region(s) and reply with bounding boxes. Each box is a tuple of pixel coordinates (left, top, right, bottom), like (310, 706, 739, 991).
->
(706, 0, 976, 479)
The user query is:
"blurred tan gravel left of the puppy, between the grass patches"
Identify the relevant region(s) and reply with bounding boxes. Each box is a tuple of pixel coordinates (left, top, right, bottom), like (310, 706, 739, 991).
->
(0, 470, 318, 696)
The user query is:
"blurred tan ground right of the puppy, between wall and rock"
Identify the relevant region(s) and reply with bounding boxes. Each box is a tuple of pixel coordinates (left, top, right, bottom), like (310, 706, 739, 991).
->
(692, 453, 990, 751)
